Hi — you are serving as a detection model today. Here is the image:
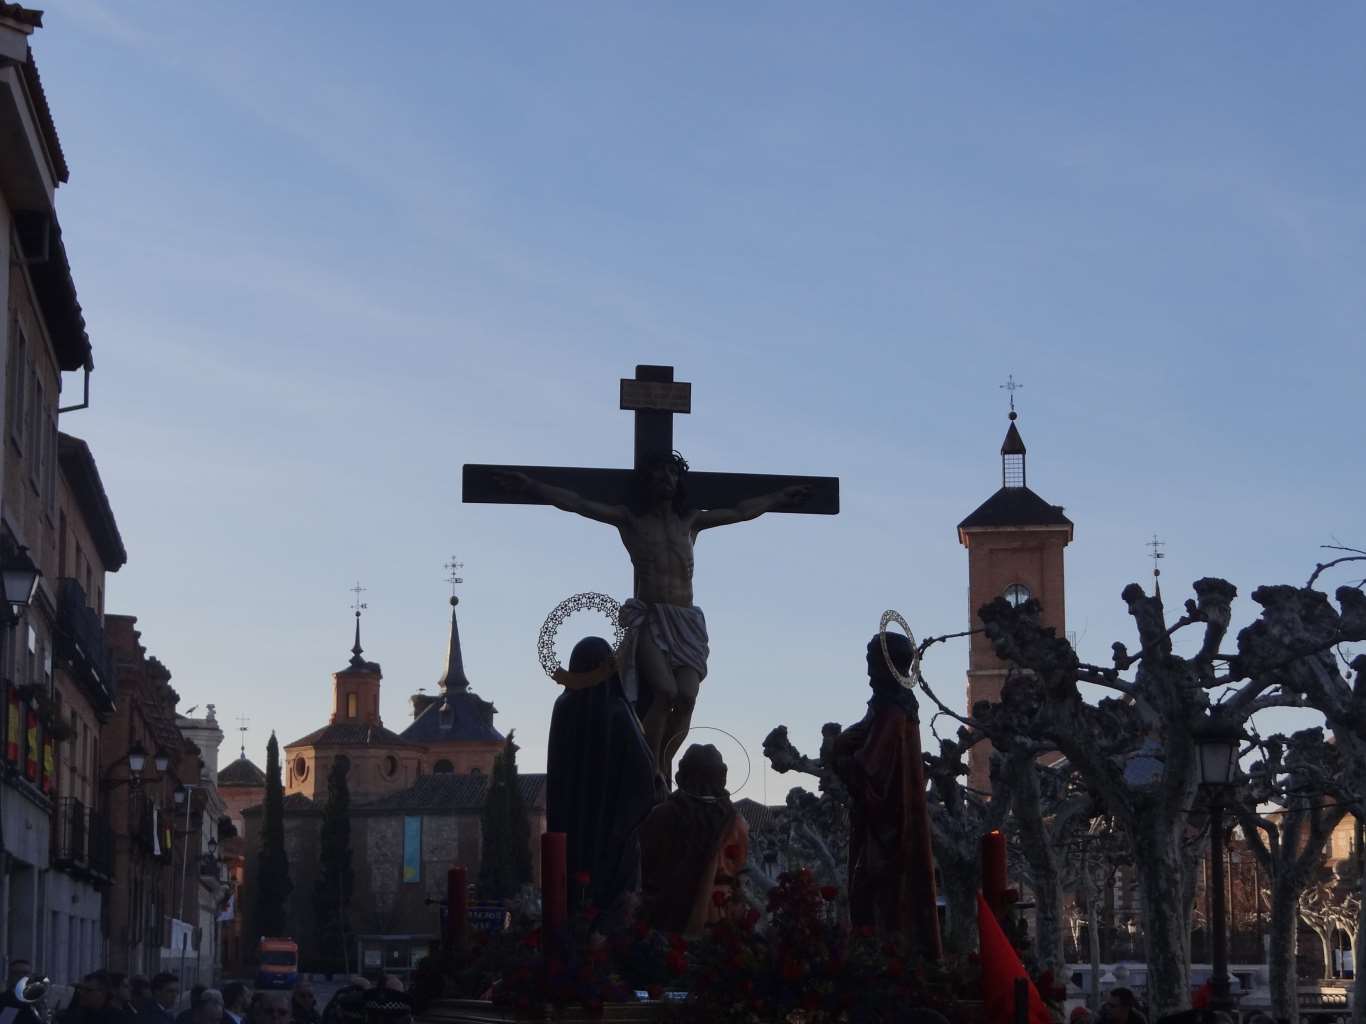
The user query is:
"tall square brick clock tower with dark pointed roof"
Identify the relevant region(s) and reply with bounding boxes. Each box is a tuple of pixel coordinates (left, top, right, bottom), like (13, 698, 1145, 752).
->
(958, 400, 1072, 792)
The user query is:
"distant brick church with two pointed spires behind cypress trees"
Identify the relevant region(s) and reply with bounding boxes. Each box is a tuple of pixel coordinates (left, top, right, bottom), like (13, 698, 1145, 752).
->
(245, 601, 545, 972)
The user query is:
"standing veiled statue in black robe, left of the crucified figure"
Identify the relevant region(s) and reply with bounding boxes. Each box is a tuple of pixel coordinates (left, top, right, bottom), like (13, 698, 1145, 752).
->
(545, 636, 656, 933)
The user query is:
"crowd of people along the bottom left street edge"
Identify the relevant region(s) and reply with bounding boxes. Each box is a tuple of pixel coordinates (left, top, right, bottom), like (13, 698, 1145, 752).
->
(0, 960, 413, 1024)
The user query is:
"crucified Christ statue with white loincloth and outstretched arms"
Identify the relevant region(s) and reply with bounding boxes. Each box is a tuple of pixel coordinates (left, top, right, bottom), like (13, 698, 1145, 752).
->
(494, 452, 811, 782)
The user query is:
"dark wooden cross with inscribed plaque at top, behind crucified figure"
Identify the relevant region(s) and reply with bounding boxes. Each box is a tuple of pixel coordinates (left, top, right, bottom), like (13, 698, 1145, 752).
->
(462, 366, 840, 516)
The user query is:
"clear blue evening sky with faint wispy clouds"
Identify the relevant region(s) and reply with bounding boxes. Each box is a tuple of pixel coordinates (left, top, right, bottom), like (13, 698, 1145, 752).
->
(24, 0, 1366, 803)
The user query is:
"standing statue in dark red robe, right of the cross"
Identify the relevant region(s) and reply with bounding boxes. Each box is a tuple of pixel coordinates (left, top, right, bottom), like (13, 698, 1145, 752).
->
(831, 634, 941, 960)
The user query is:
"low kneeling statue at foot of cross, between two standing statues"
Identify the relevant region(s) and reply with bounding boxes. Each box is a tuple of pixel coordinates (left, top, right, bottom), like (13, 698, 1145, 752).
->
(641, 743, 750, 935)
